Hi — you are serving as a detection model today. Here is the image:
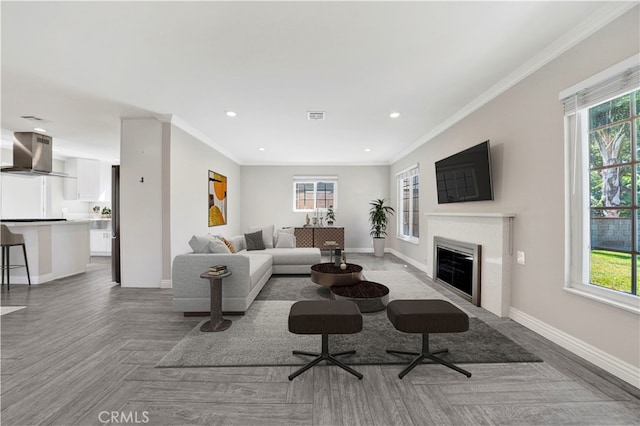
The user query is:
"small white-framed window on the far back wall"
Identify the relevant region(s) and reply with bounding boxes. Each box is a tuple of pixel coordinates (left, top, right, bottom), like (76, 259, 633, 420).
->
(293, 176, 338, 212)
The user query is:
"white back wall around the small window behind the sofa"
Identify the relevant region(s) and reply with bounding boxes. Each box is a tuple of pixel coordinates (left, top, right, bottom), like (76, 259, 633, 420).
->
(241, 166, 389, 251)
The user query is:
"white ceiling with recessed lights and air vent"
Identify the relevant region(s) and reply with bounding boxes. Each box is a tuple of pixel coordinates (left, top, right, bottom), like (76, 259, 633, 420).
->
(1, 1, 637, 164)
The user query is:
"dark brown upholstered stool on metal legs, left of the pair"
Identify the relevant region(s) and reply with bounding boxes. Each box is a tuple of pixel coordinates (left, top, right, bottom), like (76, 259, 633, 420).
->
(289, 300, 362, 380)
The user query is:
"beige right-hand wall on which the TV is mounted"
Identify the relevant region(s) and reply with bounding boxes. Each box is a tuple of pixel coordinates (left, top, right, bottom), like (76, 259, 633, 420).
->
(391, 7, 640, 378)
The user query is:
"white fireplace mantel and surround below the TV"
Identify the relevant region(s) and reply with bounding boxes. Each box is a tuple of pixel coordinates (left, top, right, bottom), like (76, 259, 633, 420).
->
(425, 212, 516, 317)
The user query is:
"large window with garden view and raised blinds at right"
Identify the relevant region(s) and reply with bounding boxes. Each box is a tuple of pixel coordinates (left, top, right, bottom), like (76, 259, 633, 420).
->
(561, 57, 640, 312)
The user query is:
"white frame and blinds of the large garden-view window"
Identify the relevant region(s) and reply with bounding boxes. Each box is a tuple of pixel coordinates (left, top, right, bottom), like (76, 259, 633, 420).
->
(560, 56, 640, 314)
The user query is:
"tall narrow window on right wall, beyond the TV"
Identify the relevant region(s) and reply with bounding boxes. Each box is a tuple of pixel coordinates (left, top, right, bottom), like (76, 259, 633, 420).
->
(396, 165, 420, 244)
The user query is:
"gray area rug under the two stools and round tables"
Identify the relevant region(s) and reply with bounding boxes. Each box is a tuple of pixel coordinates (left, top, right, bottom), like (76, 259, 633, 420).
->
(156, 271, 541, 367)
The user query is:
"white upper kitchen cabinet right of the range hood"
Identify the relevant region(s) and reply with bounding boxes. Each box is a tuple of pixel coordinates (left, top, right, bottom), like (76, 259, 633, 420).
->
(64, 158, 100, 201)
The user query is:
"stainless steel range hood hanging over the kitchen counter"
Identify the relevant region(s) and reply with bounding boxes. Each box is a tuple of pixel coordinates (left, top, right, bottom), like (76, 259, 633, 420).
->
(0, 132, 67, 177)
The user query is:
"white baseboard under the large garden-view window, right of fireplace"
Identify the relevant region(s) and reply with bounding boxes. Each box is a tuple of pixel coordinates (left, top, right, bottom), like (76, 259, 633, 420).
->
(509, 307, 640, 389)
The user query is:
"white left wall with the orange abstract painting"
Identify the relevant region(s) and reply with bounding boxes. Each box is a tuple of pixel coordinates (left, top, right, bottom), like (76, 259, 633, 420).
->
(171, 126, 241, 258)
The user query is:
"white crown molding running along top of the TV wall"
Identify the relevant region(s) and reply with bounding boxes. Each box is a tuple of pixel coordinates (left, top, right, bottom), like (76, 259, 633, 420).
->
(391, 1, 638, 164)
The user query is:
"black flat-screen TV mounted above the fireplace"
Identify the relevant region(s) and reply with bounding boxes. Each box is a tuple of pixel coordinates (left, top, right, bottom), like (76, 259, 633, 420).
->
(436, 141, 493, 204)
